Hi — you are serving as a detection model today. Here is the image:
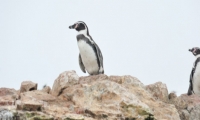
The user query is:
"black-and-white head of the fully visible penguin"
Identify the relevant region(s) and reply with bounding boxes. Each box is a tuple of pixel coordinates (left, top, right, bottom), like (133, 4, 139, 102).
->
(69, 21, 88, 32)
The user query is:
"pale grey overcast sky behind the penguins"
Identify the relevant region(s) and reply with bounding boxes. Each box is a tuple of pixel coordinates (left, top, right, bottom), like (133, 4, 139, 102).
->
(0, 0, 200, 94)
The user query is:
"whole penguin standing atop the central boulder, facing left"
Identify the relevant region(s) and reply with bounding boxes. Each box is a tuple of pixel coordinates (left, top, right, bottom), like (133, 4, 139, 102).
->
(69, 21, 104, 75)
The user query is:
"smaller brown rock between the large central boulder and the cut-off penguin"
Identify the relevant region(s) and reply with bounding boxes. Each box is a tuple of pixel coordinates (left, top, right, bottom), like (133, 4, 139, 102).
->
(146, 82, 168, 102)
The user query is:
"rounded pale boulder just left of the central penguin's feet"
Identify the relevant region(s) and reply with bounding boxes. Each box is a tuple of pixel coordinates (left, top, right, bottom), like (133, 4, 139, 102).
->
(51, 71, 79, 96)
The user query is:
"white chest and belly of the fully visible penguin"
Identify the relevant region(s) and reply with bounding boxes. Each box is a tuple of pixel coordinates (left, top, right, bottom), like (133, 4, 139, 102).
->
(78, 40, 99, 74)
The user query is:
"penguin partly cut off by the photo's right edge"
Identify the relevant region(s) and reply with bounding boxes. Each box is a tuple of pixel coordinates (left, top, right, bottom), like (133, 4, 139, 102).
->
(187, 47, 200, 95)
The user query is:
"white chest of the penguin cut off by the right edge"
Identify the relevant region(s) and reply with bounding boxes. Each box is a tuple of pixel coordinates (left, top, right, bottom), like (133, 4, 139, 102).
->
(193, 63, 200, 95)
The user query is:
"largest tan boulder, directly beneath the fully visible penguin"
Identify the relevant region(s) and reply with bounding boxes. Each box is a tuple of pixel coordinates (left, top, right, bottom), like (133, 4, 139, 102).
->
(59, 75, 180, 120)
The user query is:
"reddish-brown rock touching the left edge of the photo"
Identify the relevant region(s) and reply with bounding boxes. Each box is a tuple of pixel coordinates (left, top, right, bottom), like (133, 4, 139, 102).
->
(0, 88, 18, 106)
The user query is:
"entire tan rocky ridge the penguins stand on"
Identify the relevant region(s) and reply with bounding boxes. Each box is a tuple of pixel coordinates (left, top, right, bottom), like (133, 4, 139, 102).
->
(0, 71, 200, 120)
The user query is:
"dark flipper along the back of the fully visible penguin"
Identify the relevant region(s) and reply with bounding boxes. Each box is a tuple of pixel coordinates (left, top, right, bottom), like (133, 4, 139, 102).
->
(94, 43, 104, 74)
